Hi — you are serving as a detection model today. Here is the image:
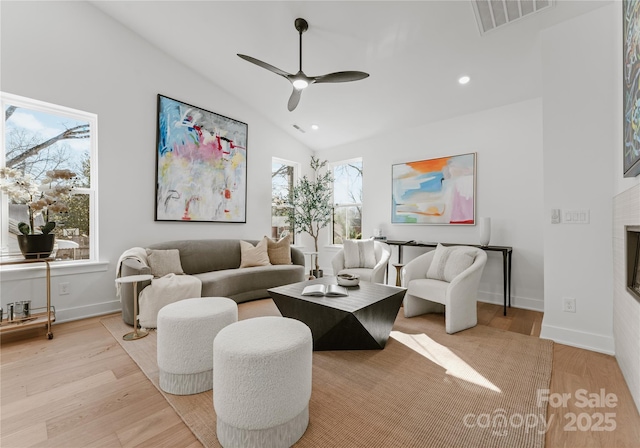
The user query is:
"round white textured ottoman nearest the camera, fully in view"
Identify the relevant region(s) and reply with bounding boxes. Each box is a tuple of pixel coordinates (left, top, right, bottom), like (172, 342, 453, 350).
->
(213, 316, 313, 448)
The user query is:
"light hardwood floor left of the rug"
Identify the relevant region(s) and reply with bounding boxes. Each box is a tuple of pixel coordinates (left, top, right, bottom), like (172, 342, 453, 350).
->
(0, 318, 201, 448)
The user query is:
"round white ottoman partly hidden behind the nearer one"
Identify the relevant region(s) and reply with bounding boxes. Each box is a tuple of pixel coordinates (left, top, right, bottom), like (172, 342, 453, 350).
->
(157, 297, 238, 395)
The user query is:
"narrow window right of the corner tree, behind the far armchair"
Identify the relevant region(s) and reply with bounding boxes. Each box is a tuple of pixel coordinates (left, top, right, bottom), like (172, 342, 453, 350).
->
(332, 158, 362, 244)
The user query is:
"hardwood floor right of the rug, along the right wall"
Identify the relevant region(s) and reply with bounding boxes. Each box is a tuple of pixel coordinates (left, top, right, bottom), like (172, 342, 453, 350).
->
(478, 303, 640, 448)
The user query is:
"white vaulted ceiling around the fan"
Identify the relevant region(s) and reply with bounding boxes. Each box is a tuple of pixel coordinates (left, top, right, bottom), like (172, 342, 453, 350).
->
(92, 0, 612, 150)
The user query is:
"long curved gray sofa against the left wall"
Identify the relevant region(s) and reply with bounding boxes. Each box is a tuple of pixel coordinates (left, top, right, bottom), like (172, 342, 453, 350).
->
(120, 239, 305, 325)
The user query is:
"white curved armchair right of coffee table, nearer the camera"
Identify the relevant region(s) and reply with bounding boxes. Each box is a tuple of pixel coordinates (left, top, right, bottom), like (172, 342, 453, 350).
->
(402, 245, 487, 334)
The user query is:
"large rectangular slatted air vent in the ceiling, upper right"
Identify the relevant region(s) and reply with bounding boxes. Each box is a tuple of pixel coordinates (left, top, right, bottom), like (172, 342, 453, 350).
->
(471, 0, 554, 34)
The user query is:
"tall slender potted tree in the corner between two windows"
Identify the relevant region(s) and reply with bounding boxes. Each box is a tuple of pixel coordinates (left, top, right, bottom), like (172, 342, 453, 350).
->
(287, 156, 333, 277)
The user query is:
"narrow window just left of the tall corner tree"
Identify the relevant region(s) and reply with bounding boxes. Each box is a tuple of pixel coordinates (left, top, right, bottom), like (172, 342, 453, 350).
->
(271, 158, 298, 244)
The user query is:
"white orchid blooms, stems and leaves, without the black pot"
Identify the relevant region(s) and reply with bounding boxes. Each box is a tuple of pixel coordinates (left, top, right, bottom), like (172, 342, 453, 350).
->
(0, 167, 76, 235)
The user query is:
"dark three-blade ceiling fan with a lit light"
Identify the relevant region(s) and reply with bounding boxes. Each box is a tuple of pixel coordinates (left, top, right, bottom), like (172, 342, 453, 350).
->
(238, 18, 369, 111)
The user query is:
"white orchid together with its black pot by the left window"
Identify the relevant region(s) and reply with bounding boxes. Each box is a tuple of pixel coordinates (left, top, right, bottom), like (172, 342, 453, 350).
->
(0, 168, 76, 258)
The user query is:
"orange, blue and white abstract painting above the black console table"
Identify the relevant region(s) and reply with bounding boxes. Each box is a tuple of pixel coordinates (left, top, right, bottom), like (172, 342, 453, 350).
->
(391, 153, 476, 225)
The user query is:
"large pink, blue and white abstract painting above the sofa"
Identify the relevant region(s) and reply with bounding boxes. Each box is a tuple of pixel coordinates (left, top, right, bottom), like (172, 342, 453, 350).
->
(155, 95, 248, 223)
